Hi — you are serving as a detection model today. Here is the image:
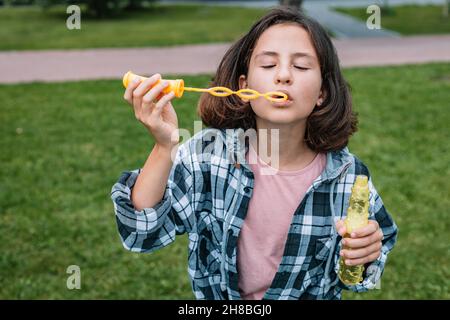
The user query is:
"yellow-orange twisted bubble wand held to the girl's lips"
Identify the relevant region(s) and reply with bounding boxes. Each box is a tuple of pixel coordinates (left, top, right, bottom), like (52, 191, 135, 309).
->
(122, 71, 288, 102)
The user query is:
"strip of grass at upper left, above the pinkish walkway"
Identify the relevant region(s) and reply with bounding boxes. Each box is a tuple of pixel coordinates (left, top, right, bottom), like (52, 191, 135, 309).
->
(0, 4, 265, 50)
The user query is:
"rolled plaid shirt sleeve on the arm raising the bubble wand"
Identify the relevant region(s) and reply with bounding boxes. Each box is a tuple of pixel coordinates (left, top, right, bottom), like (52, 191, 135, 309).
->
(111, 144, 194, 252)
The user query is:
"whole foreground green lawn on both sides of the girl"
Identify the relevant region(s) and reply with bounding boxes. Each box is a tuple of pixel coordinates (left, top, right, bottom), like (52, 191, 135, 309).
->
(0, 64, 450, 299)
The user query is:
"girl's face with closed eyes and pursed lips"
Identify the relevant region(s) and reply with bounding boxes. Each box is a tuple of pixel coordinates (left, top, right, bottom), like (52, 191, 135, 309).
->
(239, 24, 323, 124)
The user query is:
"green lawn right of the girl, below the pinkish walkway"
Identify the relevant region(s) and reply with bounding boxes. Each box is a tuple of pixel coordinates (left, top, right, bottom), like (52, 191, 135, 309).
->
(345, 64, 450, 299)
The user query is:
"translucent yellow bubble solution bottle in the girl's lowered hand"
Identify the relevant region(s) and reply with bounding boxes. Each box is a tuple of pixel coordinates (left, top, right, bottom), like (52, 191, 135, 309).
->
(338, 175, 369, 285)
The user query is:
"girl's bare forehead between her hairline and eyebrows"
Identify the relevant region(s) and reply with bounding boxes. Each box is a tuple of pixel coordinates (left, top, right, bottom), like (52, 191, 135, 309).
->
(252, 23, 316, 59)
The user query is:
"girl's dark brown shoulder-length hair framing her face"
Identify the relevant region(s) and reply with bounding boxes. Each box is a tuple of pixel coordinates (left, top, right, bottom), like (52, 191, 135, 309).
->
(197, 7, 358, 152)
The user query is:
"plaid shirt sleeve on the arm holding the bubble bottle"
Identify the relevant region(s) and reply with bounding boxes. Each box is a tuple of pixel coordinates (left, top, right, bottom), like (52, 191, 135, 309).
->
(335, 177, 398, 292)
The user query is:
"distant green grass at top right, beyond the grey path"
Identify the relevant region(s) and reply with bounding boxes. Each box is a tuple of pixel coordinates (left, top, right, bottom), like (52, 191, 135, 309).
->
(334, 5, 450, 35)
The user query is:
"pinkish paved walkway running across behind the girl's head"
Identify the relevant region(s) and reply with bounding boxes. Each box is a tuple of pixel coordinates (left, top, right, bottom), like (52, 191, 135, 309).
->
(0, 35, 450, 83)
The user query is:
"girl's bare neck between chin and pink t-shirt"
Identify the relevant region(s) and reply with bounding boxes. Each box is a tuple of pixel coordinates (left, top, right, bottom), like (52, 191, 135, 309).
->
(252, 118, 317, 170)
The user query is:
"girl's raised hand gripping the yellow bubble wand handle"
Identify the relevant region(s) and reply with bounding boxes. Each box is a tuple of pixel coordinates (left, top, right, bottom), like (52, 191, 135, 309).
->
(124, 74, 179, 150)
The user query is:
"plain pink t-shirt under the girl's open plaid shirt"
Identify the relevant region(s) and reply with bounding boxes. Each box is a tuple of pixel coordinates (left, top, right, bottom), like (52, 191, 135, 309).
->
(237, 144, 326, 300)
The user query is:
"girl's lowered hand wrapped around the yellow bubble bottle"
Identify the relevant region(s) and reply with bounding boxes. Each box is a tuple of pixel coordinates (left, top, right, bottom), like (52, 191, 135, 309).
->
(336, 220, 383, 266)
